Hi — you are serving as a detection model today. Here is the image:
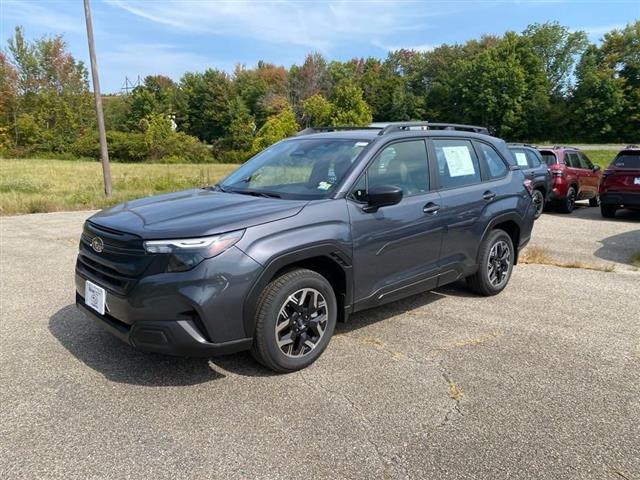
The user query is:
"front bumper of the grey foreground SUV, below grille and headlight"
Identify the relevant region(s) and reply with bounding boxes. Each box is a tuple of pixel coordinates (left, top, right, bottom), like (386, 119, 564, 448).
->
(75, 247, 262, 356)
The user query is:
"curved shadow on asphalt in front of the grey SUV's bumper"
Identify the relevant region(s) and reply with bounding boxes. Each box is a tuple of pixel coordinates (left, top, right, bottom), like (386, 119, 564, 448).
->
(49, 305, 224, 387)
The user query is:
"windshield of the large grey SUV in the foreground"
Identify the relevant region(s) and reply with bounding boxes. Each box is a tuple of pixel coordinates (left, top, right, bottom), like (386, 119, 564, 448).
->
(218, 138, 369, 200)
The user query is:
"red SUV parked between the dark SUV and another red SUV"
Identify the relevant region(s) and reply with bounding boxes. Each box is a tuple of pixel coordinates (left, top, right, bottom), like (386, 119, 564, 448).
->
(539, 147, 602, 213)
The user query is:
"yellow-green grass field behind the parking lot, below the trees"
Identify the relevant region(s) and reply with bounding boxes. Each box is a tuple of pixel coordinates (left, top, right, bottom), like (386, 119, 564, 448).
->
(0, 150, 616, 215)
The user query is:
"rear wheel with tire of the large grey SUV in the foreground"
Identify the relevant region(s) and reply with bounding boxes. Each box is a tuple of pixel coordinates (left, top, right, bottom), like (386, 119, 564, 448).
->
(467, 229, 515, 297)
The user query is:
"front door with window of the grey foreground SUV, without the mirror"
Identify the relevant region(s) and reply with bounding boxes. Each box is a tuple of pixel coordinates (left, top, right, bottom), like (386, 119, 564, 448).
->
(347, 138, 442, 310)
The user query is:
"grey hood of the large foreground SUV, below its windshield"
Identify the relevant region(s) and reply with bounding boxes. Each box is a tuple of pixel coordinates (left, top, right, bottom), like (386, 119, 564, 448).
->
(89, 189, 308, 240)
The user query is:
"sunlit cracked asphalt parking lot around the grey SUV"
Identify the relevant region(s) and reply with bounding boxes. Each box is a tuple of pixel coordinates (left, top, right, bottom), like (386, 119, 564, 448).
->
(0, 204, 640, 479)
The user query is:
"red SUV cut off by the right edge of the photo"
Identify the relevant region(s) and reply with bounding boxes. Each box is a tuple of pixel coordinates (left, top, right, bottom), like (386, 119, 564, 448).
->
(600, 145, 640, 218)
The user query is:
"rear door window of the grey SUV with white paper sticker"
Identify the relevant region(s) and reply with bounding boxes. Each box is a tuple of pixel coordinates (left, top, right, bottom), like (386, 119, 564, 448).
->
(433, 139, 482, 188)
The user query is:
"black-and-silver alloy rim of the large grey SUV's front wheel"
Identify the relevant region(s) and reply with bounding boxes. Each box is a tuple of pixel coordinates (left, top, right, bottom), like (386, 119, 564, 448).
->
(275, 288, 329, 358)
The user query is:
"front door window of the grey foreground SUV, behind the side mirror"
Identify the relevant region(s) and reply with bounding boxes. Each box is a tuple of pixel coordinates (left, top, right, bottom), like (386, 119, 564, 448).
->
(351, 140, 429, 202)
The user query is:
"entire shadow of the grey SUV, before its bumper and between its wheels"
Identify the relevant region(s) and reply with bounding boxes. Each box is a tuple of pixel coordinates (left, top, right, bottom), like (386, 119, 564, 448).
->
(49, 282, 475, 387)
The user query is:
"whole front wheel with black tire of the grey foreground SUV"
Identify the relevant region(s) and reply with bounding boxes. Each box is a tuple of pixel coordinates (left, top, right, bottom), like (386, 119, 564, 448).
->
(251, 269, 338, 372)
